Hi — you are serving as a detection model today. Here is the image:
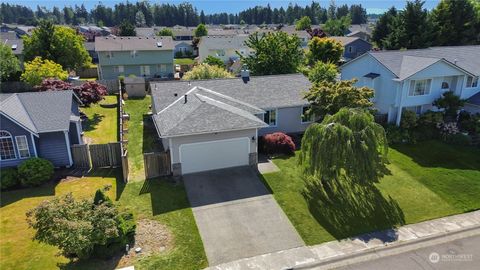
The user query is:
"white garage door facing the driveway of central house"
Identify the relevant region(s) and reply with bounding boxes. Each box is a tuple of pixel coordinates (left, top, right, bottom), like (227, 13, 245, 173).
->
(180, 138, 250, 174)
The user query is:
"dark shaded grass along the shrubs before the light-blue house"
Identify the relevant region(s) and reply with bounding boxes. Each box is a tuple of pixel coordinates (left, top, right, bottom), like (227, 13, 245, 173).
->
(390, 141, 480, 170)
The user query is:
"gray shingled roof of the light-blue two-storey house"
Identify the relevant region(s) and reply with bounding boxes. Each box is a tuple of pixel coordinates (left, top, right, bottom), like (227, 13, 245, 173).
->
(370, 45, 480, 79)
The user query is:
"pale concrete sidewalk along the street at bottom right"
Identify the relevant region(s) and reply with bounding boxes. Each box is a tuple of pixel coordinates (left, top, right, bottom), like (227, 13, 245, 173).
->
(207, 210, 480, 270)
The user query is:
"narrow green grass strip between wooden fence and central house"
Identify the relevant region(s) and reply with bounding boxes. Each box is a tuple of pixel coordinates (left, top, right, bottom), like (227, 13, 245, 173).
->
(124, 96, 158, 181)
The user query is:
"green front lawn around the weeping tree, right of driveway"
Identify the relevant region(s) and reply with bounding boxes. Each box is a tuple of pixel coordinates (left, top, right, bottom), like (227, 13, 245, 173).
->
(263, 141, 480, 245)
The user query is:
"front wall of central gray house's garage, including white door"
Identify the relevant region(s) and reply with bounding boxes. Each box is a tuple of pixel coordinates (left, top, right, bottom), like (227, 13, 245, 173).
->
(166, 129, 257, 174)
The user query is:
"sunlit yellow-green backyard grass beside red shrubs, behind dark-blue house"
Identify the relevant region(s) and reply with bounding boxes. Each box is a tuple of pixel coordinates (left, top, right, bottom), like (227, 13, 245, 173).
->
(81, 96, 118, 144)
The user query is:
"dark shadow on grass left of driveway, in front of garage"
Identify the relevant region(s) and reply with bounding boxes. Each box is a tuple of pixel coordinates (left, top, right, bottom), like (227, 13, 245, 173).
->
(139, 177, 190, 216)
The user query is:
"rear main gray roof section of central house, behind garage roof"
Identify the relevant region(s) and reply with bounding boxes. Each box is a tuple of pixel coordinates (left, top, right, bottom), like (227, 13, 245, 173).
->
(150, 74, 311, 111)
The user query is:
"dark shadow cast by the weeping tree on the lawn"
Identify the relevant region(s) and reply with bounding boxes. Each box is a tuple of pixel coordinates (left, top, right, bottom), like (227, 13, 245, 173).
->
(302, 177, 405, 242)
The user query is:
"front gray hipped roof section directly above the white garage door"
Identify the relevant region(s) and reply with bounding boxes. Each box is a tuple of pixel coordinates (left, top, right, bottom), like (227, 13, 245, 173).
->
(153, 87, 267, 137)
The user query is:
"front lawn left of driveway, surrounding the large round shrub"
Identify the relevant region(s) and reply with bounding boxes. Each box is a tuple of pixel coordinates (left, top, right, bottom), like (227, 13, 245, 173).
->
(0, 170, 207, 269)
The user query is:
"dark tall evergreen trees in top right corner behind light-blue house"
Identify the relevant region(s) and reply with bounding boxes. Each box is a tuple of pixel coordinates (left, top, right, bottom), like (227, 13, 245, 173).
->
(372, 0, 480, 49)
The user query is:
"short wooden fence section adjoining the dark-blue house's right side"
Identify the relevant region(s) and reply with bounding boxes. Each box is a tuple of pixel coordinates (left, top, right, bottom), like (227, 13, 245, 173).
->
(90, 142, 122, 168)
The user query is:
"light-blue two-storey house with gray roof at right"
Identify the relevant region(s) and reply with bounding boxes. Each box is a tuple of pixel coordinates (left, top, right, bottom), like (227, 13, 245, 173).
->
(341, 46, 480, 125)
